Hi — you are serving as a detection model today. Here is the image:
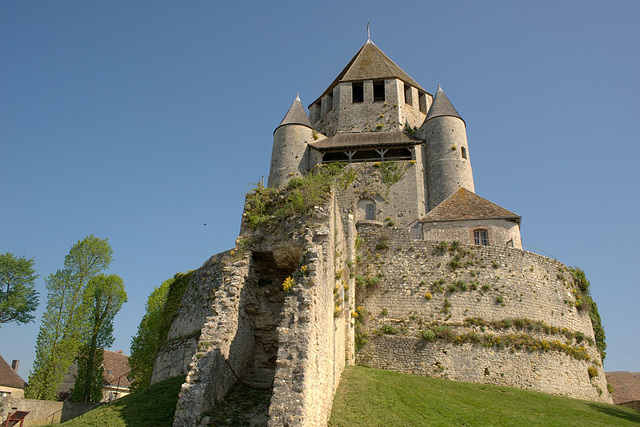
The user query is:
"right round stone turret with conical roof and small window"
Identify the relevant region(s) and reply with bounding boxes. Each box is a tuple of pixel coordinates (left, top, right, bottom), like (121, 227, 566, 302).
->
(416, 85, 475, 210)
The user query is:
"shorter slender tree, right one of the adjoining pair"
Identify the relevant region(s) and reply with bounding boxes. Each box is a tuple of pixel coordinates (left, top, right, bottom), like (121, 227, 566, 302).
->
(71, 274, 127, 402)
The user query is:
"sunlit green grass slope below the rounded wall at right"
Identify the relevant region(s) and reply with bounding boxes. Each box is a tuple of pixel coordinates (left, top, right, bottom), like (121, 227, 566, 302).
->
(329, 367, 640, 426)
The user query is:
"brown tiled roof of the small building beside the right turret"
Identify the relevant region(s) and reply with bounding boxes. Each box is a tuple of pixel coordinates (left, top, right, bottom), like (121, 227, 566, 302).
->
(421, 188, 520, 223)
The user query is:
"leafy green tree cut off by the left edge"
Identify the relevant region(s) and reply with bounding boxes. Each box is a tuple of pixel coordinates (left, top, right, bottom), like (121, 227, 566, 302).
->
(0, 252, 38, 325)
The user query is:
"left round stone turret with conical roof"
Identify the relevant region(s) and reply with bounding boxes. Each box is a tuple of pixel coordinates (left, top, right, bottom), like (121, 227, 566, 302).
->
(268, 96, 318, 191)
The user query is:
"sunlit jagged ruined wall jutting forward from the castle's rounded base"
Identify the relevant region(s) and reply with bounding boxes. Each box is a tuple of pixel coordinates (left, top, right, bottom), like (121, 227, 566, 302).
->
(269, 194, 355, 426)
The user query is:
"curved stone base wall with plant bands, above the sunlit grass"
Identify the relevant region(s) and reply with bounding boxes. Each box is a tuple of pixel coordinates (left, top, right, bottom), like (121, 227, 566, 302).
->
(357, 226, 611, 402)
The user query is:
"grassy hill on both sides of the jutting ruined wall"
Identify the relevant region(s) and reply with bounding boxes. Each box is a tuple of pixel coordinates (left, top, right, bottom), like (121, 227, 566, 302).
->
(56, 367, 640, 427)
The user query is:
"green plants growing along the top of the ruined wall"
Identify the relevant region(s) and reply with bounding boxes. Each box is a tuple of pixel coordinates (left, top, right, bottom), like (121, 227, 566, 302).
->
(245, 163, 356, 228)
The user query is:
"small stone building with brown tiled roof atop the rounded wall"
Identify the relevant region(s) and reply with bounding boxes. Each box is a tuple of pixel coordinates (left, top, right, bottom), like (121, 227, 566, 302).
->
(418, 188, 522, 249)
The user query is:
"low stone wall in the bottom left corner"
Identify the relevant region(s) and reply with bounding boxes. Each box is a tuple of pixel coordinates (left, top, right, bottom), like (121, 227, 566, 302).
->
(0, 397, 100, 427)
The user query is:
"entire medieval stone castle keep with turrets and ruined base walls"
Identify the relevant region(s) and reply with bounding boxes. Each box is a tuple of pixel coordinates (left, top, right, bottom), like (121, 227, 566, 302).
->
(152, 36, 611, 427)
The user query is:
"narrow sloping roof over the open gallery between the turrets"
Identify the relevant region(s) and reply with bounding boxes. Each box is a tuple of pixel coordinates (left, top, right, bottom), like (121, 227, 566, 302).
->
(309, 131, 422, 151)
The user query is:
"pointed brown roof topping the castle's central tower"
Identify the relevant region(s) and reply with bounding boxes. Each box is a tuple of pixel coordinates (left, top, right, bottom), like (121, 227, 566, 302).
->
(312, 40, 426, 105)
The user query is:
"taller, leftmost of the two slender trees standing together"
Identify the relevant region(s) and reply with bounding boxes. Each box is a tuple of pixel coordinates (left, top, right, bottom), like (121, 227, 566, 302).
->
(25, 235, 113, 400)
